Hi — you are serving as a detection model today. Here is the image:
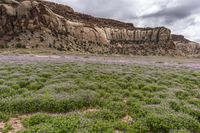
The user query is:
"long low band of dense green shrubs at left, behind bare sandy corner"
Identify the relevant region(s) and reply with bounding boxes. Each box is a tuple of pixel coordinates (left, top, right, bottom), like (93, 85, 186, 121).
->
(0, 90, 100, 114)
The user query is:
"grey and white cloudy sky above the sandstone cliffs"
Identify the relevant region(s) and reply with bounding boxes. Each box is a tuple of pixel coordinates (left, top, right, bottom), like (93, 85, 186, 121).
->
(51, 0, 200, 42)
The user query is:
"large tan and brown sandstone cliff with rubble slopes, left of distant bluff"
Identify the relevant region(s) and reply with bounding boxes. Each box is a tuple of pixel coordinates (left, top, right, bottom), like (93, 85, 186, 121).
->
(0, 0, 199, 55)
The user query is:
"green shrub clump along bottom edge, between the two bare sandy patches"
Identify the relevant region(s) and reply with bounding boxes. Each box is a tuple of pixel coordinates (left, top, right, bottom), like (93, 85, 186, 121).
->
(24, 115, 114, 133)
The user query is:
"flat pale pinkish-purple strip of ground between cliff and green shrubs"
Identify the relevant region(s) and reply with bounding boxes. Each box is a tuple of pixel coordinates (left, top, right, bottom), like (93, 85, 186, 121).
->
(0, 55, 200, 70)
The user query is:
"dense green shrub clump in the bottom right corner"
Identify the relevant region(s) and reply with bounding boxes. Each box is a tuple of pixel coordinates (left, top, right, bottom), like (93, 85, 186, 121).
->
(134, 114, 200, 133)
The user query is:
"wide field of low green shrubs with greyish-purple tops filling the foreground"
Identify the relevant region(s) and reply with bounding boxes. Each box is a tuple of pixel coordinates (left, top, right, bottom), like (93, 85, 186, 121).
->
(0, 63, 200, 133)
